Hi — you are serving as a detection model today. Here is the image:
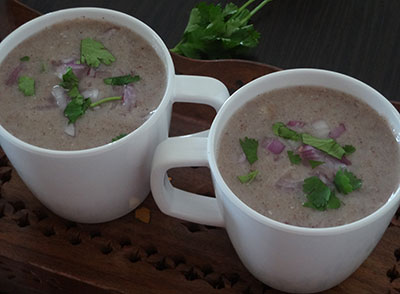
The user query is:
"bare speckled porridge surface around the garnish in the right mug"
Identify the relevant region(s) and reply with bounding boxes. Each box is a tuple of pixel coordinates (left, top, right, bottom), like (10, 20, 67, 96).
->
(217, 87, 400, 227)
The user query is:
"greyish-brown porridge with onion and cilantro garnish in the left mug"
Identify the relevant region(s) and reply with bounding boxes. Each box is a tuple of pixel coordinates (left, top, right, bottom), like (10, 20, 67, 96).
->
(0, 18, 166, 150)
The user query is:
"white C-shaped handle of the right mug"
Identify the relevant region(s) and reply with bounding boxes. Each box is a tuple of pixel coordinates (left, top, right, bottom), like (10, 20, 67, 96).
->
(150, 136, 224, 227)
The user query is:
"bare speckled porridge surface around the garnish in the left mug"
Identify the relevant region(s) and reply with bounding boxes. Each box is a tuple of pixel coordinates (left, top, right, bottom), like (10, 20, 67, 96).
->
(0, 19, 166, 150)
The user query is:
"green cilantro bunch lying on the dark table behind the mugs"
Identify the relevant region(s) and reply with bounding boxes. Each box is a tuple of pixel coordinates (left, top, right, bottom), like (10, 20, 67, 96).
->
(171, 0, 271, 59)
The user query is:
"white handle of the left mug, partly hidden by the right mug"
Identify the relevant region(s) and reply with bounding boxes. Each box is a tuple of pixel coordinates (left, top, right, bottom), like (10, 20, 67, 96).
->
(173, 75, 229, 111)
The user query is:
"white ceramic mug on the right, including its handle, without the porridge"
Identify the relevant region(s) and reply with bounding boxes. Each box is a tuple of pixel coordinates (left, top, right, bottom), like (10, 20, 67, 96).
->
(151, 69, 400, 293)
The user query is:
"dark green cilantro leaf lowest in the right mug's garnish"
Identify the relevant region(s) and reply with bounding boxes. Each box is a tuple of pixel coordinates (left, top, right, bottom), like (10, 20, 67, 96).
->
(303, 176, 340, 211)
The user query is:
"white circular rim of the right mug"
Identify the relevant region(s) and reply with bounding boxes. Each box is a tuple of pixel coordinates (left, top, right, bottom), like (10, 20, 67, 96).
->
(207, 68, 400, 236)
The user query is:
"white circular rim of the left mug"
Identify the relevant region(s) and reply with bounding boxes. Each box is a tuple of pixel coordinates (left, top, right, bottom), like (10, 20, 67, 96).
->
(0, 7, 175, 157)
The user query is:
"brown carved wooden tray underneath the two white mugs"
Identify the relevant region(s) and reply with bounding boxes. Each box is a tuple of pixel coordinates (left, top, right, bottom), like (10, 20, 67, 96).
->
(0, 1, 400, 294)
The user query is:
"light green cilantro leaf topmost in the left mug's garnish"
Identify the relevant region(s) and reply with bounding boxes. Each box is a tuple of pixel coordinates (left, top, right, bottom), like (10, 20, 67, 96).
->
(81, 38, 115, 67)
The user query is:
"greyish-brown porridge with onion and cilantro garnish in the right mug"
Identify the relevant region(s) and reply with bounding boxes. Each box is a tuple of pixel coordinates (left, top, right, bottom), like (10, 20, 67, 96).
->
(217, 86, 400, 228)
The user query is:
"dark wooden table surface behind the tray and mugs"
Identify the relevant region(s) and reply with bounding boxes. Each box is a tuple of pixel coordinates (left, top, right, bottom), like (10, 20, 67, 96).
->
(15, 0, 400, 101)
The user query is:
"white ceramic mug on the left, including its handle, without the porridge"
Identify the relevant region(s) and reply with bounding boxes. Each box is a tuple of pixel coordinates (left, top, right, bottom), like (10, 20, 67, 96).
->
(0, 8, 229, 223)
